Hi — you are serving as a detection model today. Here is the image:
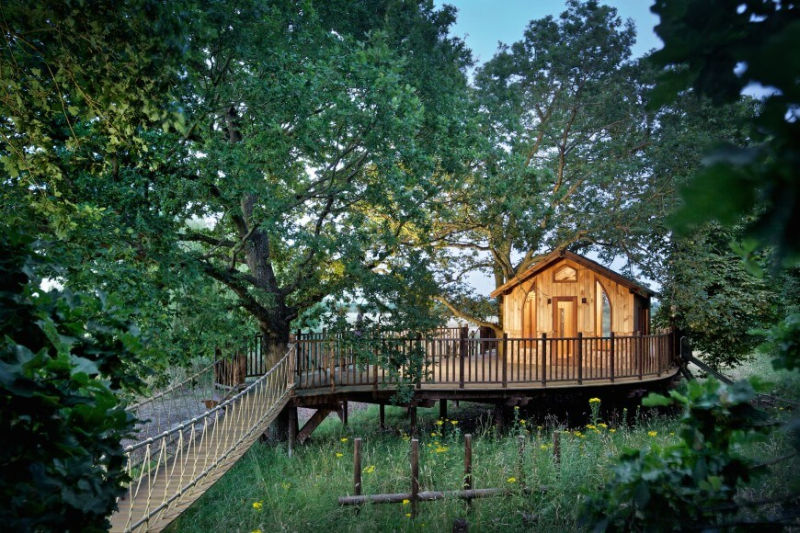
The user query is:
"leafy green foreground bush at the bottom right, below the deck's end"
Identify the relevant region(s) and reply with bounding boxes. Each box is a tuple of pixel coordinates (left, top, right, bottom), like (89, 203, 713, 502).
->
(581, 380, 768, 531)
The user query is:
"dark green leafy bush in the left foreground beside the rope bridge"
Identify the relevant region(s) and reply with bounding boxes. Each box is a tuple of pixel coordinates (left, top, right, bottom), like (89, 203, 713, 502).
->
(0, 226, 137, 531)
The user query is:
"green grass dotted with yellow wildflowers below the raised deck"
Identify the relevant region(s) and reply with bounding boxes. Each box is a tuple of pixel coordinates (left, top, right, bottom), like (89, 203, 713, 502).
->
(169, 352, 800, 533)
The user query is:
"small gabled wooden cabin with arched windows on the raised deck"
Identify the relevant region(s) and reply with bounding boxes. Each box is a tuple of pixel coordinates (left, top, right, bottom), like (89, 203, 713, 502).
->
(491, 251, 655, 338)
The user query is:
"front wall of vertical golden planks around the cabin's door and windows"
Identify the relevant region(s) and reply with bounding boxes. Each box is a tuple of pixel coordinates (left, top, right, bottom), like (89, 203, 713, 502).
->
(503, 259, 635, 338)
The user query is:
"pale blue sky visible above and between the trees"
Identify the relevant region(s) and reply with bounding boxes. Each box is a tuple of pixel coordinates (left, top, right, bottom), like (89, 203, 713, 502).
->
(435, 0, 663, 295)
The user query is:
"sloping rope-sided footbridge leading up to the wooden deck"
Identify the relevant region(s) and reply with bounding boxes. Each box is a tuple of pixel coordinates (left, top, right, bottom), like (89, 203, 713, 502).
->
(110, 346, 296, 531)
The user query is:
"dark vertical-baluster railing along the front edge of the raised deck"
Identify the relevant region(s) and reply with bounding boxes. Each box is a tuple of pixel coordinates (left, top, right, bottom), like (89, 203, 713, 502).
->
(295, 333, 678, 390)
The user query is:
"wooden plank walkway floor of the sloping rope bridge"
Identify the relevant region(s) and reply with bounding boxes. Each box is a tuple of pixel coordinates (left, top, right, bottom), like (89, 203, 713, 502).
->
(110, 390, 291, 532)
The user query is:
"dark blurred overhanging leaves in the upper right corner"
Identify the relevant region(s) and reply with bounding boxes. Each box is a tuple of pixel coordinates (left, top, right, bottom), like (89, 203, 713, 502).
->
(653, 0, 800, 266)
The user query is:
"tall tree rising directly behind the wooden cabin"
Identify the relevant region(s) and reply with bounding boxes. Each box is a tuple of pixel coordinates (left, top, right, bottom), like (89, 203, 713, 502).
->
(428, 1, 657, 333)
